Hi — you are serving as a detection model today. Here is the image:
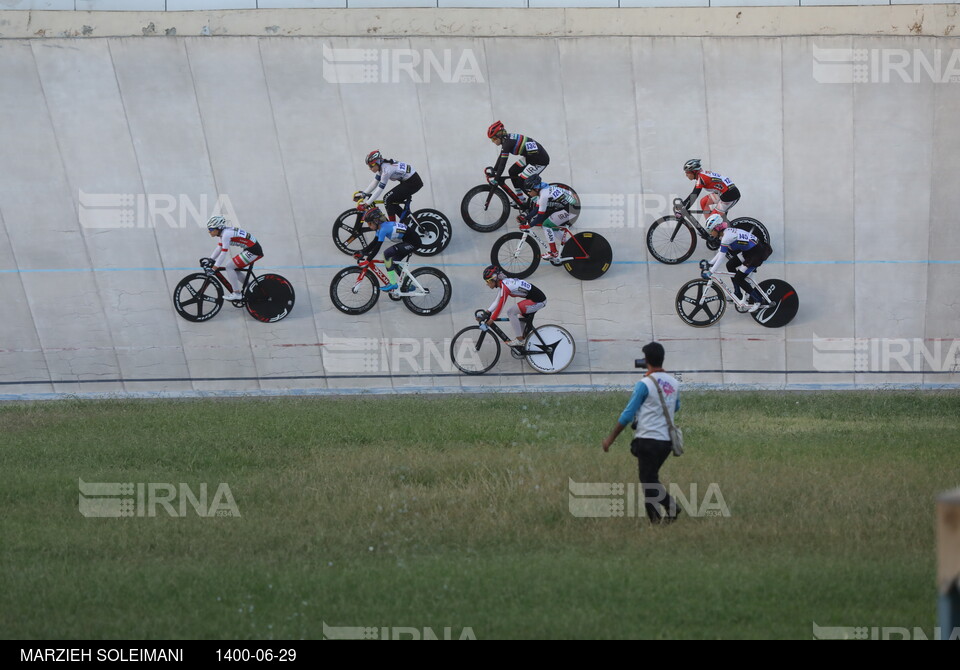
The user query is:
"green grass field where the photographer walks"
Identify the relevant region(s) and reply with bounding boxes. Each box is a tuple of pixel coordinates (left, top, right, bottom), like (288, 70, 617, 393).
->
(0, 392, 960, 640)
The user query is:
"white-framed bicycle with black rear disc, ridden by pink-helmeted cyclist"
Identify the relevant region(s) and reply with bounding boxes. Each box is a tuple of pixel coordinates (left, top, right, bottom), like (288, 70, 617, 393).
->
(675, 260, 800, 328)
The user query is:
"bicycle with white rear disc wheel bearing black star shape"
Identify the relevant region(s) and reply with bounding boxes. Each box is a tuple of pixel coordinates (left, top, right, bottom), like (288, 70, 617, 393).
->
(450, 309, 577, 375)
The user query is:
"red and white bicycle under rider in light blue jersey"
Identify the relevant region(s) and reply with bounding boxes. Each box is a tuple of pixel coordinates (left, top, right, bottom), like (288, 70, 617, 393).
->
(330, 259, 451, 316)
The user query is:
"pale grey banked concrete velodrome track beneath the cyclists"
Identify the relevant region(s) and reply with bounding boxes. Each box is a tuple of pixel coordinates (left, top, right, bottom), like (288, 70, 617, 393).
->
(0, 7, 960, 399)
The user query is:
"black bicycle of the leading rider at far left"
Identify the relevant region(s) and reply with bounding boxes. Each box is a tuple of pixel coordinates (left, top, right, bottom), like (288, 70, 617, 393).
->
(173, 258, 296, 323)
